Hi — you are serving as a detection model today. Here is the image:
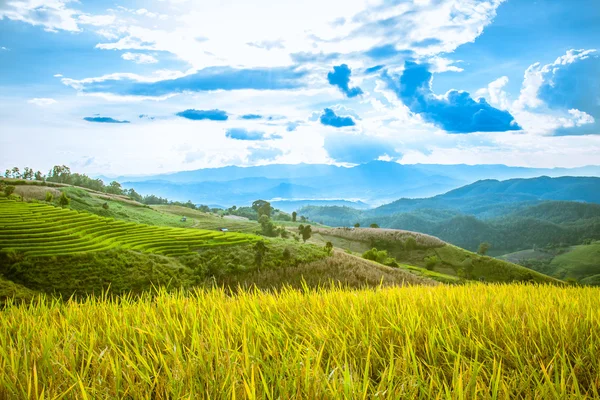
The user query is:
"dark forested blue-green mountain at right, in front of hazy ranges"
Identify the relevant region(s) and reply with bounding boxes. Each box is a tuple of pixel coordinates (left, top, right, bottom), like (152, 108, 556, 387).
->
(299, 177, 600, 254)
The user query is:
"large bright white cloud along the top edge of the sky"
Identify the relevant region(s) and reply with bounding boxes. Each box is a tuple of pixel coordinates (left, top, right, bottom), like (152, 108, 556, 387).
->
(92, 0, 503, 71)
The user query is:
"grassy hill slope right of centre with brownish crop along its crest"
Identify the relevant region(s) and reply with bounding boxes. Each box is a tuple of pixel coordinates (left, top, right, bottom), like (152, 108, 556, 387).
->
(315, 228, 559, 283)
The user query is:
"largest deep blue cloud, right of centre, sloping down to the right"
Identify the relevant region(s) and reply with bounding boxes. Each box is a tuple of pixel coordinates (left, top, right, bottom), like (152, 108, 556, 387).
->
(384, 61, 521, 133)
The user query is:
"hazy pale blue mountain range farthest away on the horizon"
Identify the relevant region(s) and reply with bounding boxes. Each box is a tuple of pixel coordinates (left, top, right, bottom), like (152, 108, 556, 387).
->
(117, 161, 600, 206)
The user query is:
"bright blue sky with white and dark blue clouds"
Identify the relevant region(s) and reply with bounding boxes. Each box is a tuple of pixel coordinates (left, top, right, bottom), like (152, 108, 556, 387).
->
(0, 0, 600, 175)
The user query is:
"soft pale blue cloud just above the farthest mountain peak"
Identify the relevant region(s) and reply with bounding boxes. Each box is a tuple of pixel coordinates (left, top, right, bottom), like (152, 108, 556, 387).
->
(324, 133, 402, 164)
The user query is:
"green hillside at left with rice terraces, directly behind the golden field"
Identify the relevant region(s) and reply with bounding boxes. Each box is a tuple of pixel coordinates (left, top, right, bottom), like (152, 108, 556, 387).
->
(0, 195, 436, 303)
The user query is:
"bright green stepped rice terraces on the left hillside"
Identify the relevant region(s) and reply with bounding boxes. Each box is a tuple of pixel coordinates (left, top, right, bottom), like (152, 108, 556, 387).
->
(0, 199, 259, 257)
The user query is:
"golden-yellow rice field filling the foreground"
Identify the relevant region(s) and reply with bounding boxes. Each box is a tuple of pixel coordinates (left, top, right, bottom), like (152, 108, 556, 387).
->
(0, 284, 600, 399)
